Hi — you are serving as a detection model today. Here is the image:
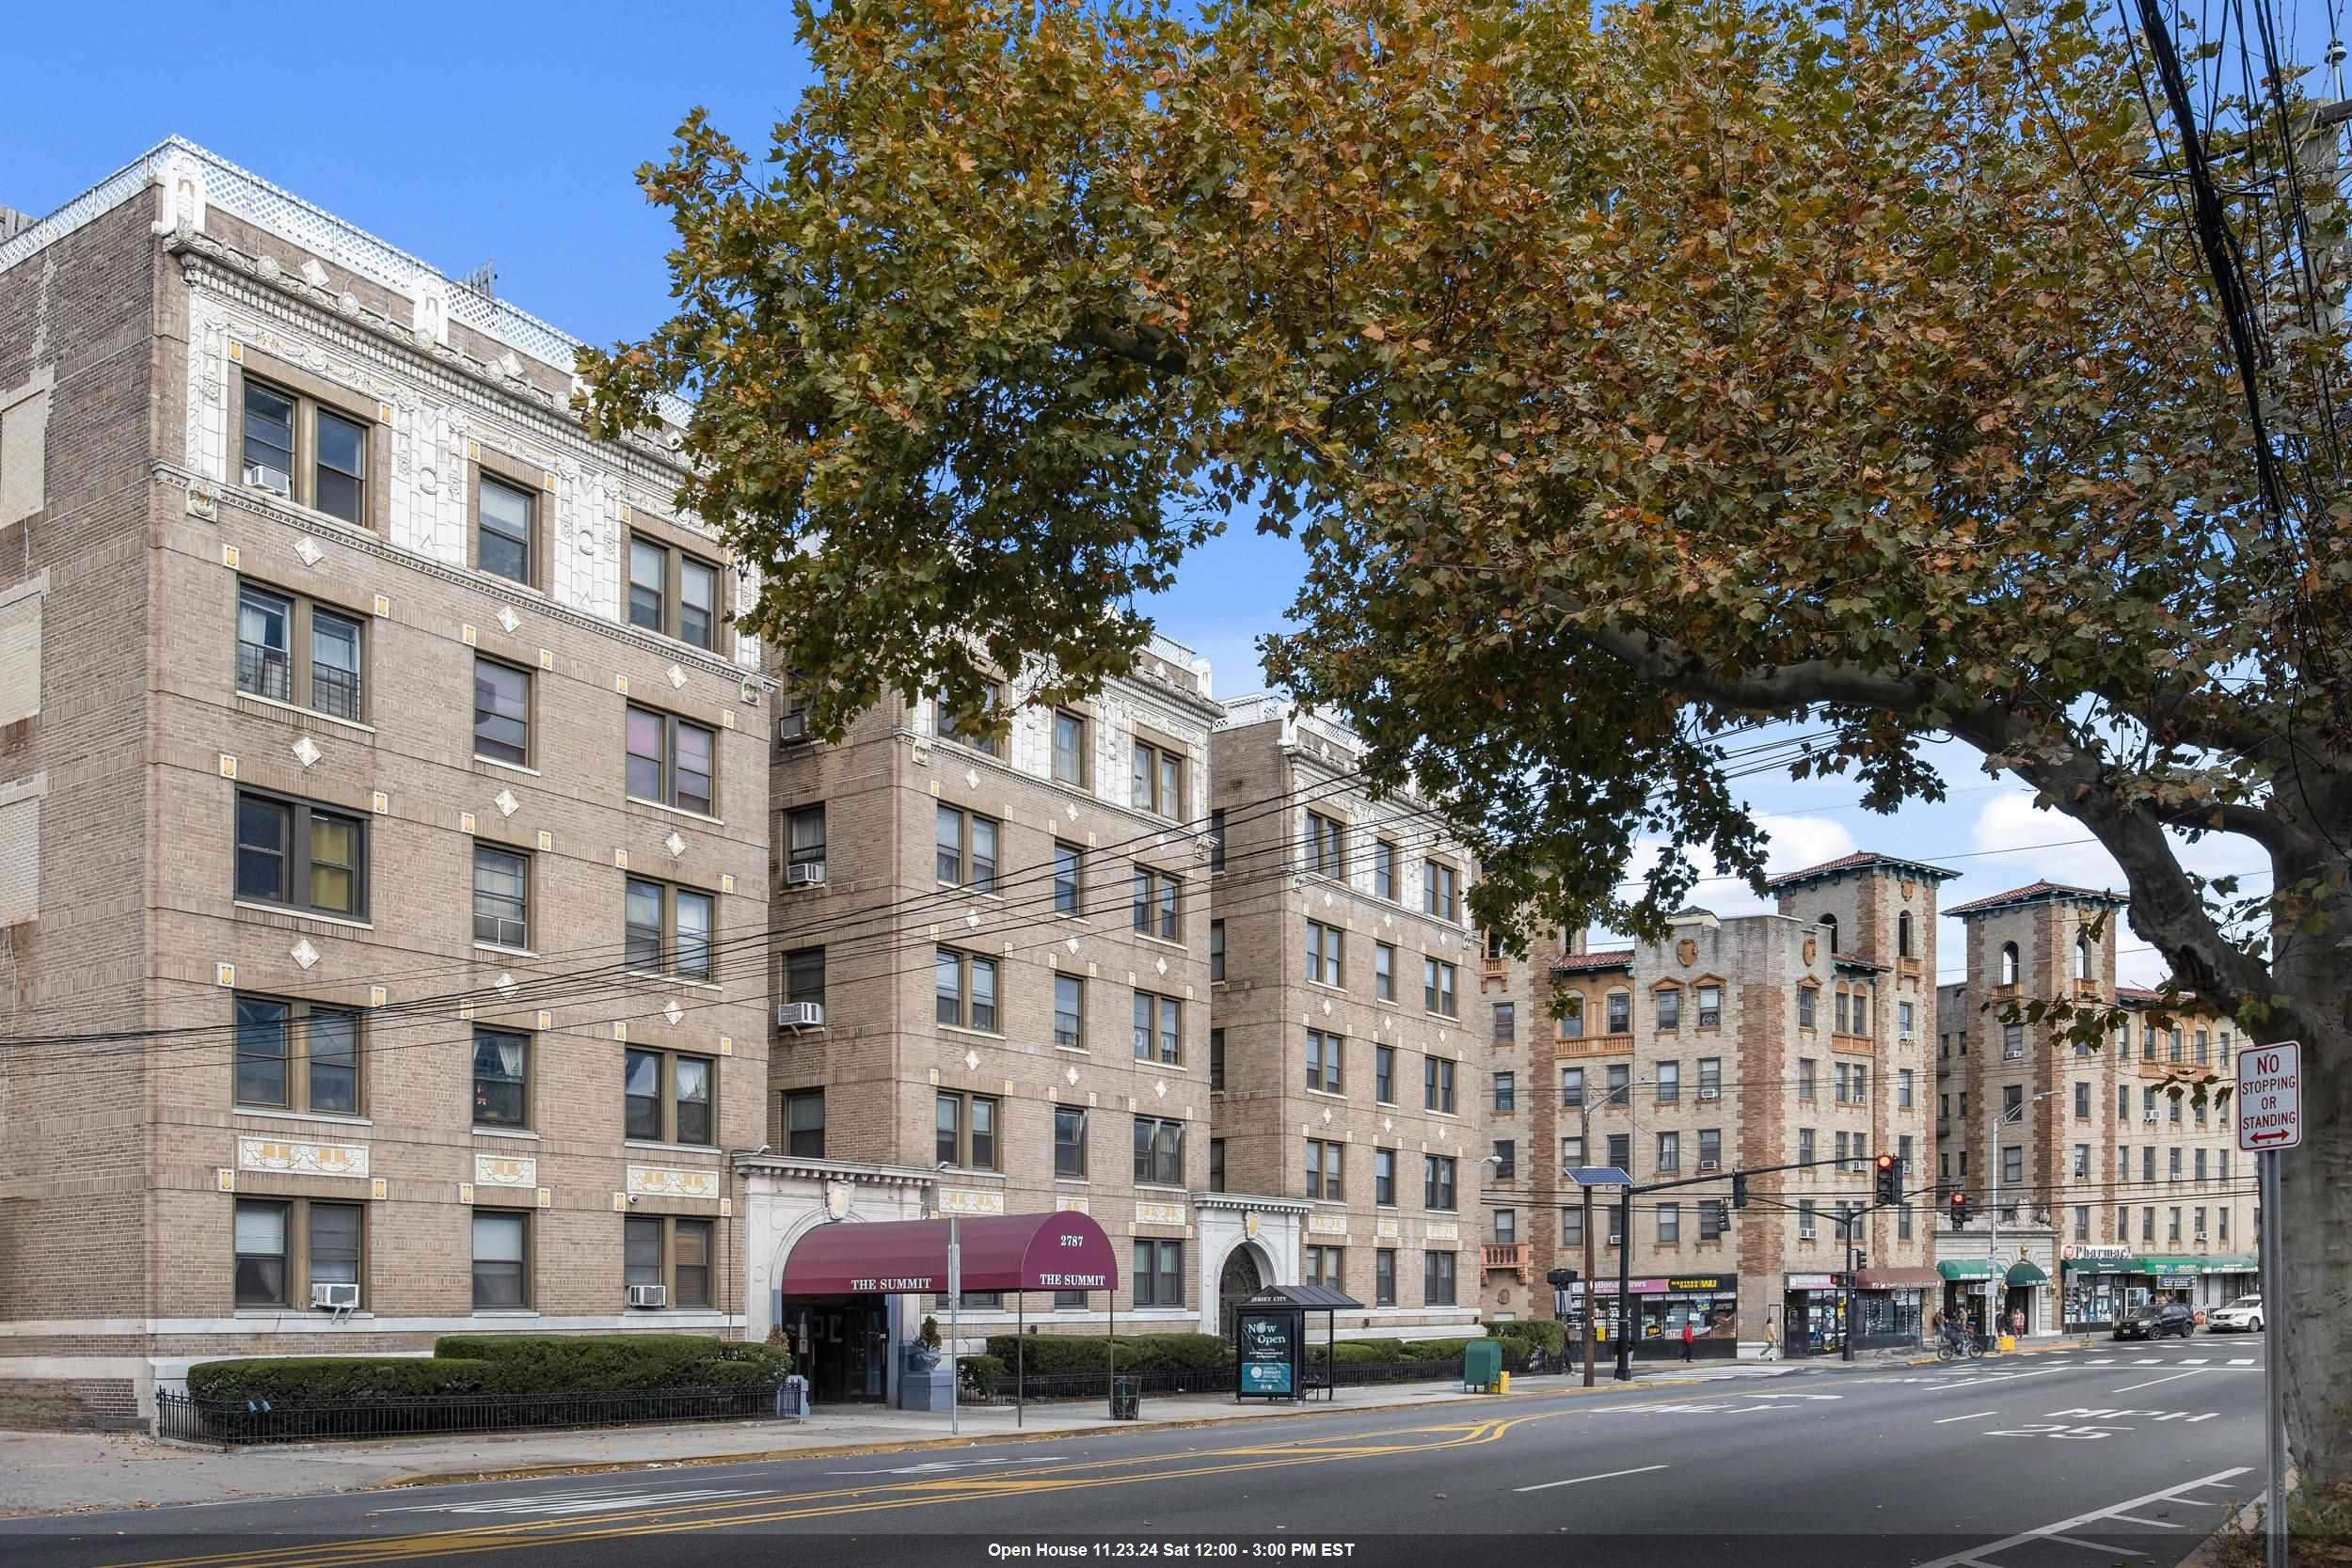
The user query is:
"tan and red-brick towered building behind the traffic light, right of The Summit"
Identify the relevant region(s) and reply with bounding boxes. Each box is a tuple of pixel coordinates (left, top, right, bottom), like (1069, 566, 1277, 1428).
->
(1482, 853, 1952, 1356)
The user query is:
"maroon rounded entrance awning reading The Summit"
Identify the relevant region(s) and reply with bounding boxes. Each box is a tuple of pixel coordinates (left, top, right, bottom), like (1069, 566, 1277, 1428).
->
(776, 1209, 1120, 1295)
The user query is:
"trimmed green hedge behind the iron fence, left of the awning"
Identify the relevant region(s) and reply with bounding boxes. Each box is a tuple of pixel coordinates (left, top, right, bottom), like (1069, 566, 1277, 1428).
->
(188, 1333, 793, 1403)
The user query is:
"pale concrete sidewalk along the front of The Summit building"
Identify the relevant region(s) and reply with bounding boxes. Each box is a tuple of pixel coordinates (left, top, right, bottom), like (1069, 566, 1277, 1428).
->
(0, 1366, 1675, 1516)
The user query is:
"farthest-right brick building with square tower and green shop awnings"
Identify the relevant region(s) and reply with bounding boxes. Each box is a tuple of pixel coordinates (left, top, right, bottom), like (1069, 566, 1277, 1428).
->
(1936, 881, 2258, 1331)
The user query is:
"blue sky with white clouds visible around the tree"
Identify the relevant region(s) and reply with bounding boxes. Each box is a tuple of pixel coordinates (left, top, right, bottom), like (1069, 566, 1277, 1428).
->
(0, 2, 2277, 983)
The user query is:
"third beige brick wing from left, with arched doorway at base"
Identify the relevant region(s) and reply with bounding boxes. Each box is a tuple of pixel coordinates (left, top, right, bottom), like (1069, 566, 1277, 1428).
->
(1202, 696, 1494, 1338)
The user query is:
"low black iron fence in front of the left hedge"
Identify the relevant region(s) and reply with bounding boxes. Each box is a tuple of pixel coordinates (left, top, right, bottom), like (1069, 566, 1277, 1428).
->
(155, 1385, 779, 1444)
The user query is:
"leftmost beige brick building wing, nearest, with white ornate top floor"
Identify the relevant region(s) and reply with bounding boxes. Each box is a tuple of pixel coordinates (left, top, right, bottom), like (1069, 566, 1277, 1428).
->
(0, 141, 771, 1425)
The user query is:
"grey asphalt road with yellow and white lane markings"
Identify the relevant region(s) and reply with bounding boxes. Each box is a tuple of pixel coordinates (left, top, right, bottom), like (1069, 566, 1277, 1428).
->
(5, 1336, 2263, 1568)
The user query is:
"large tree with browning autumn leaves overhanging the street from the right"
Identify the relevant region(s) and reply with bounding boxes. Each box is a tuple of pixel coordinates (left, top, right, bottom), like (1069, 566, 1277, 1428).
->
(583, 0, 2352, 1479)
